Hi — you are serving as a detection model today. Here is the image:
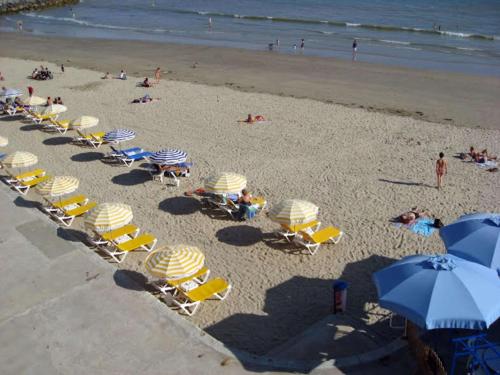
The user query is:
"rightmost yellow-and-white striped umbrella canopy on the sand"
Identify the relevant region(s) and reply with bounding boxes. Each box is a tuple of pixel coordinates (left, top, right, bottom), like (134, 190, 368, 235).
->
(269, 199, 319, 225)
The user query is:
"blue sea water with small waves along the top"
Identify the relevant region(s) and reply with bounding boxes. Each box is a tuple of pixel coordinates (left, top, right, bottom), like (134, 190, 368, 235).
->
(0, 0, 500, 76)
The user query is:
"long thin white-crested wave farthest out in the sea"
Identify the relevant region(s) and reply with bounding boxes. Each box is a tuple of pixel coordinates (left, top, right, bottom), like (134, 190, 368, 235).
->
(169, 9, 500, 40)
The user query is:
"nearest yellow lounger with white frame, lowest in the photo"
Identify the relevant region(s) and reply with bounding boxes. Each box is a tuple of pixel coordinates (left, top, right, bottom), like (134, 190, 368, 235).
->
(173, 278, 231, 316)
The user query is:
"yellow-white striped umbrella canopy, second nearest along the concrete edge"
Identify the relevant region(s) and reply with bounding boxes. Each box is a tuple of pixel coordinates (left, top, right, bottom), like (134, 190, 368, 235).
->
(85, 203, 134, 233)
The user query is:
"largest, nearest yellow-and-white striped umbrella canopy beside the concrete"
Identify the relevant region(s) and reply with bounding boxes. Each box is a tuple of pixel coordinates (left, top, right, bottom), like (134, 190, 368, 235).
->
(144, 245, 205, 279)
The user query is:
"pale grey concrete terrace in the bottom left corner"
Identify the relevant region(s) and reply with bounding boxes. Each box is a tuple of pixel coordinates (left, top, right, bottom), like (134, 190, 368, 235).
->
(0, 185, 414, 375)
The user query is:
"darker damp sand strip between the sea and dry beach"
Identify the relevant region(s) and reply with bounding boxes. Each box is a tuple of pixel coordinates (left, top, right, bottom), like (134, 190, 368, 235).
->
(0, 32, 500, 129)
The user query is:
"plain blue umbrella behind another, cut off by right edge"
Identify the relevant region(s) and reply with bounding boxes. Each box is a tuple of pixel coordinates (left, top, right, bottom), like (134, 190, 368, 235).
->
(439, 213, 500, 272)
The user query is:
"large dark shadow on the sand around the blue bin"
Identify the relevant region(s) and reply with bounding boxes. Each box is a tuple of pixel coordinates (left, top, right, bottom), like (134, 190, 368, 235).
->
(205, 255, 400, 374)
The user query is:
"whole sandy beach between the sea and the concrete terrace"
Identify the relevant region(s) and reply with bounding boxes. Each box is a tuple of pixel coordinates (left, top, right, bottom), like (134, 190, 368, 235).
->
(0, 51, 500, 354)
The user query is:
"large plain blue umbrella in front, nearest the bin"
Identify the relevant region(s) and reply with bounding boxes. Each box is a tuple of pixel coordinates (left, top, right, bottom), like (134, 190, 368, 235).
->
(373, 254, 500, 329)
